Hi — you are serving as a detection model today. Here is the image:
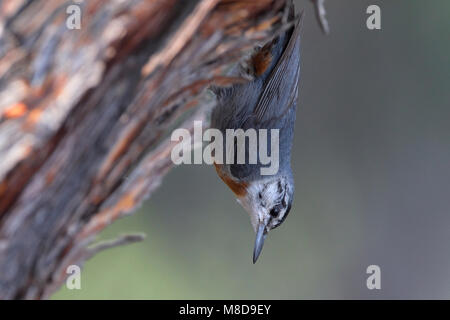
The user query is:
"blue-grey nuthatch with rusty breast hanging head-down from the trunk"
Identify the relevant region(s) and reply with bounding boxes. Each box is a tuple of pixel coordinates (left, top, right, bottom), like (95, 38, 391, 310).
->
(210, 4, 303, 264)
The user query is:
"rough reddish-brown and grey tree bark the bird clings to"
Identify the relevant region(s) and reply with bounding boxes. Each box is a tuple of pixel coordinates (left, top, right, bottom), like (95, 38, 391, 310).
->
(0, 0, 292, 299)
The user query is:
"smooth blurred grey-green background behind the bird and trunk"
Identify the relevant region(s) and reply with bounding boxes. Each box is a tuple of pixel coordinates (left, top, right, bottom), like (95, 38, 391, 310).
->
(54, 0, 450, 299)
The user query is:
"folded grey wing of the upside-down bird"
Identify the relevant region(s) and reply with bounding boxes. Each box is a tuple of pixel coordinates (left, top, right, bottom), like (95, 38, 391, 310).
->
(253, 17, 302, 122)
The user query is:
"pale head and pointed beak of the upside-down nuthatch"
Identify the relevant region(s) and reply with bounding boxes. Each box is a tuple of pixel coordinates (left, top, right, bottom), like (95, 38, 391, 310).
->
(237, 176, 294, 263)
